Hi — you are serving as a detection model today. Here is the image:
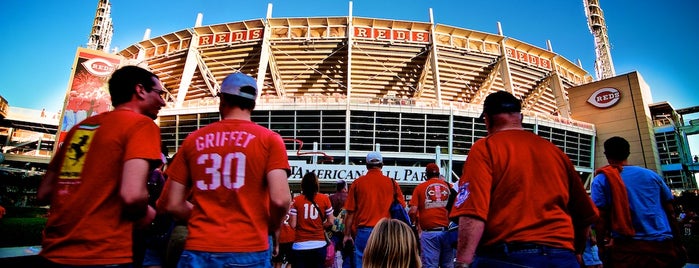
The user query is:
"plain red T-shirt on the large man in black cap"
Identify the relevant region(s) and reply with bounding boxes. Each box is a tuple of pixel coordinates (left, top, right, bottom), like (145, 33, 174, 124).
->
(450, 130, 597, 250)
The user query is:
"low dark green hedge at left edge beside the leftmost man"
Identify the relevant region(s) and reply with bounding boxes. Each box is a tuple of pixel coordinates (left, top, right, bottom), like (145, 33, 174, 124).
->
(0, 217, 46, 247)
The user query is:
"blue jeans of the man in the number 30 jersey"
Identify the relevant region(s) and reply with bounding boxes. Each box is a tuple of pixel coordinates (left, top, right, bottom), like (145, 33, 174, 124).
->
(177, 250, 272, 268)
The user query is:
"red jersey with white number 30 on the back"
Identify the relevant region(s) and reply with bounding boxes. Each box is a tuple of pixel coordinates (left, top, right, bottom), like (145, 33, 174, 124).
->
(166, 119, 290, 252)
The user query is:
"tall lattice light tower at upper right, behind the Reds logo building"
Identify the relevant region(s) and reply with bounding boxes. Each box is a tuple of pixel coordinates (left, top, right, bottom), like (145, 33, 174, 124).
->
(583, 0, 616, 80)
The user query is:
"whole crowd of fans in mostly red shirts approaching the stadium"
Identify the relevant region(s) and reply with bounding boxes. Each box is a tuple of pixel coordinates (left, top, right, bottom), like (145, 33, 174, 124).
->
(32, 66, 682, 268)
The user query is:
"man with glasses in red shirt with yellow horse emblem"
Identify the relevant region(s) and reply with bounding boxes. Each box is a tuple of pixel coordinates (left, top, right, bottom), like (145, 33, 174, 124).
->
(37, 66, 166, 267)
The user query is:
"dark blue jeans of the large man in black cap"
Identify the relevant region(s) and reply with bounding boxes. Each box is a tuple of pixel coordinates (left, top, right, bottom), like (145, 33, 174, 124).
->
(471, 246, 580, 268)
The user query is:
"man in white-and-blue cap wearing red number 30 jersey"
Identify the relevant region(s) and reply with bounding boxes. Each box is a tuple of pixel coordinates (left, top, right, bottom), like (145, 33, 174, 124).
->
(158, 72, 291, 267)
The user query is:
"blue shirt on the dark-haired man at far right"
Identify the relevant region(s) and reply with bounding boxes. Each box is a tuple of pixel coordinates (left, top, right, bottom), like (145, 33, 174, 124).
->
(590, 166, 673, 241)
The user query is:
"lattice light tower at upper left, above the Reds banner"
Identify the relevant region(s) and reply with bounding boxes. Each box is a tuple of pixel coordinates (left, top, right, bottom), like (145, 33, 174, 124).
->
(87, 0, 114, 52)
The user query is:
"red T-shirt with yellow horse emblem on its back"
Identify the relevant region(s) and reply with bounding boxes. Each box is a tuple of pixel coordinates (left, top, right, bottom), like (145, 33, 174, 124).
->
(39, 110, 160, 265)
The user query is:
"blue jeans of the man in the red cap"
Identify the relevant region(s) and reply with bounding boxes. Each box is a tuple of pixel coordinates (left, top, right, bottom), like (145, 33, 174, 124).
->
(420, 231, 454, 268)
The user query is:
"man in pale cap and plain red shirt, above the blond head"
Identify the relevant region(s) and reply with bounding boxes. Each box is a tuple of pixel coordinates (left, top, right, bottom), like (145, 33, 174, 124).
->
(343, 152, 405, 267)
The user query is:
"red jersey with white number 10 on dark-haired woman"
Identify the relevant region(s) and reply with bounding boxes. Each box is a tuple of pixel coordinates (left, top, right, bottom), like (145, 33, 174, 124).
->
(289, 193, 333, 242)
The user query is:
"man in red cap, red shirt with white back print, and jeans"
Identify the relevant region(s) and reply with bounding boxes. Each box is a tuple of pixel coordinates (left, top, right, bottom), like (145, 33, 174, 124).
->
(408, 163, 454, 268)
